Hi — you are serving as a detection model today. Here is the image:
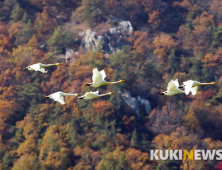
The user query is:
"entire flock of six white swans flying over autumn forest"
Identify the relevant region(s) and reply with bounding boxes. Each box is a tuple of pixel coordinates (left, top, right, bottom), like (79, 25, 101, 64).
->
(23, 63, 217, 105)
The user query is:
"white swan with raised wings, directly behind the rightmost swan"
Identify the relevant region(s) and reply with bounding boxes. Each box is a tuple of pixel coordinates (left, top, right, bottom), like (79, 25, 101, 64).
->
(160, 79, 185, 96)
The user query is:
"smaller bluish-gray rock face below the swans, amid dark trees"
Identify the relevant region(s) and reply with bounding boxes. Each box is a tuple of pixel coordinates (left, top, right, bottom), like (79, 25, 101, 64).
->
(120, 90, 151, 115)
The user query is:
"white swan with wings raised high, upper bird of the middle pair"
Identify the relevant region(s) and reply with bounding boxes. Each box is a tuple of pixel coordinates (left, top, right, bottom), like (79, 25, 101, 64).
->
(85, 68, 125, 87)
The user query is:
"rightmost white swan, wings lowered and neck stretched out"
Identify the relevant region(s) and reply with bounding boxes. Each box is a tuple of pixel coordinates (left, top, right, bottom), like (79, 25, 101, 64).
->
(179, 80, 217, 95)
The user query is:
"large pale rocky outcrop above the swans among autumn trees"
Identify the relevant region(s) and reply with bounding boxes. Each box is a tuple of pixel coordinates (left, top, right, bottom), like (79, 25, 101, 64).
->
(79, 16, 133, 54)
